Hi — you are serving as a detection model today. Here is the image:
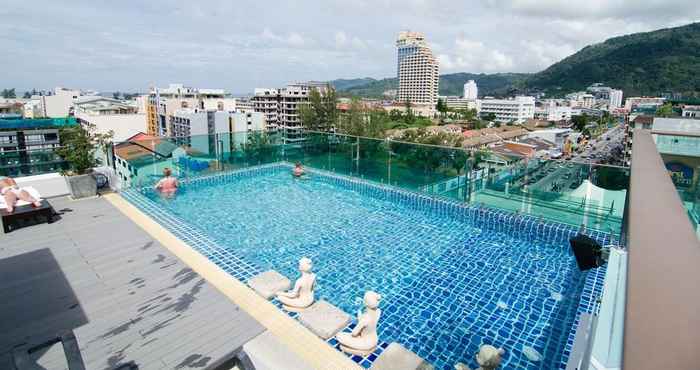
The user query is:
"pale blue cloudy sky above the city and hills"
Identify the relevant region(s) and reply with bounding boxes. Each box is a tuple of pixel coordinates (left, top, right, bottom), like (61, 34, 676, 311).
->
(0, 0, 700, 94)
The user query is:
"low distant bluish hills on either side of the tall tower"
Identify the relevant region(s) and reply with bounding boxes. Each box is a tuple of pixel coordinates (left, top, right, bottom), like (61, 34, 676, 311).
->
(331, 73, 528, 98)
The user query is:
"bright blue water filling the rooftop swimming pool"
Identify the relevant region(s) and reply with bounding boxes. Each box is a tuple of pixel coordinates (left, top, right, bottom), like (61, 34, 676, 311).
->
(141, 169, 586, 369)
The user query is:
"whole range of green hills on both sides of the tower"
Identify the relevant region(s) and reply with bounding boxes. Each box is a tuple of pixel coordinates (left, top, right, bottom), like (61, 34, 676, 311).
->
(331, 23, 700, 98)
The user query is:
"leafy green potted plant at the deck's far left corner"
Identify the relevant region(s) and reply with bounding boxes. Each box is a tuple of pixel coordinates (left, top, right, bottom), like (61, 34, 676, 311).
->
(57, 124, 113, 199)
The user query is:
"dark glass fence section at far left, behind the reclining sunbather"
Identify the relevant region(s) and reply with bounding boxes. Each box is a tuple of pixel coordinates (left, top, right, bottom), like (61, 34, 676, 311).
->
(0, 148, 68, 177)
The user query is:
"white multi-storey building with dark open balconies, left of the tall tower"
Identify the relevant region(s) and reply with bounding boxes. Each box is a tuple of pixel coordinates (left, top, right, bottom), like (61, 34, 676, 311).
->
(251, 82, 327, 143)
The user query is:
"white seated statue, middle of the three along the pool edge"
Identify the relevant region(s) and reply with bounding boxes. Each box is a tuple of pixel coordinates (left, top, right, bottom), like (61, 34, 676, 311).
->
(335, 291, 382, 356)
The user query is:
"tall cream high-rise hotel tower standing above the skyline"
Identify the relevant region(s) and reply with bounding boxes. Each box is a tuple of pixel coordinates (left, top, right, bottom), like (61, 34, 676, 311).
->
(396, 31, 440, 105)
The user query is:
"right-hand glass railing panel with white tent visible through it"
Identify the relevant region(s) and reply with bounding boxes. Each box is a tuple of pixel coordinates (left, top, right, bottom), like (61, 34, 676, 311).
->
(470, 160, 629, 234)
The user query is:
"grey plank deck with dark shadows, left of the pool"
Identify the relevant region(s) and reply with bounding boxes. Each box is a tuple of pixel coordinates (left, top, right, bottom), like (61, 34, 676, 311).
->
(0, 198, 263, 369)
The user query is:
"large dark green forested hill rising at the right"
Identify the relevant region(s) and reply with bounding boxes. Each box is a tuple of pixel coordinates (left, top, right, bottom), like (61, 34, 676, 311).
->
(520, 23, 700, 96)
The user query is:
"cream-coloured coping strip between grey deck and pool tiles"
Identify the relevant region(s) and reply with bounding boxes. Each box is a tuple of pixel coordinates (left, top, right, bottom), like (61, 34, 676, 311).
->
(104, 193, 362, 370)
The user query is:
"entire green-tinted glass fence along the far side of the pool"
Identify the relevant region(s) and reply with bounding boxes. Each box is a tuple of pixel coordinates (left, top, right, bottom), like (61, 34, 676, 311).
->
(115, 131, 629, 234)
